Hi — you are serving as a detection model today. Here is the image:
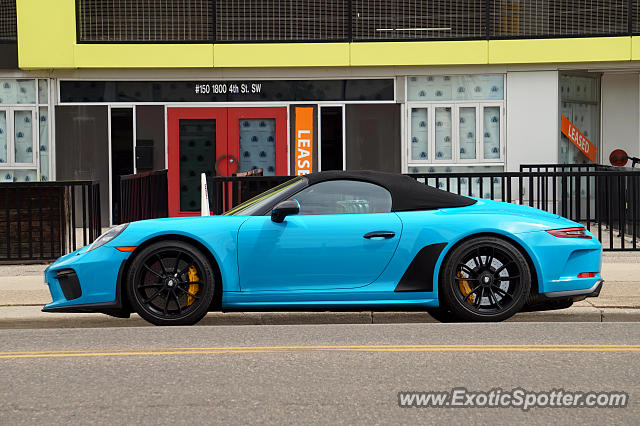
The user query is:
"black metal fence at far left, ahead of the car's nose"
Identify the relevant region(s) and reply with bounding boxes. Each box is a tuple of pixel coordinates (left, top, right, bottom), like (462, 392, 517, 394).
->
(0, 181, 101, 262)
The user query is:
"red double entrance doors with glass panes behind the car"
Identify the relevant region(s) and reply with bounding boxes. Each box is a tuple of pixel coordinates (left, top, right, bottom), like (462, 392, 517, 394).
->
(167, 107, 288, 216)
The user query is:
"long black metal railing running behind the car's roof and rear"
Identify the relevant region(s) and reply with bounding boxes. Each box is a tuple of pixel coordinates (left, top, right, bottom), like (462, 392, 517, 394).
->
(208, 169, 640, 251)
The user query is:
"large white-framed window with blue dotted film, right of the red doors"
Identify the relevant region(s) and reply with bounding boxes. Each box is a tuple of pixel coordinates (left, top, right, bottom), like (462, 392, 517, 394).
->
(407, 74, 505, 170)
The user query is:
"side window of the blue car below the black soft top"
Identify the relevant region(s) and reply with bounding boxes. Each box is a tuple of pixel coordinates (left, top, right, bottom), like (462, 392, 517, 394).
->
(291, 180, 391, 215)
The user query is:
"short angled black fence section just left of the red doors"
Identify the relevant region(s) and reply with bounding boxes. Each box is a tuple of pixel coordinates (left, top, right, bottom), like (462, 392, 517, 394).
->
(120, 170, 168, 223)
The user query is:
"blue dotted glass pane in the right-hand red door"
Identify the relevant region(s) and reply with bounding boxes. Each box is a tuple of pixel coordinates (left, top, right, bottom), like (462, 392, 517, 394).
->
(238, 118, 276, 176)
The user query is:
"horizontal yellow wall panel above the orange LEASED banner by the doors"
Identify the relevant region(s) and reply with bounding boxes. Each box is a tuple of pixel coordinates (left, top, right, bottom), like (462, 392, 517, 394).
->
(213, 43, 349, 68)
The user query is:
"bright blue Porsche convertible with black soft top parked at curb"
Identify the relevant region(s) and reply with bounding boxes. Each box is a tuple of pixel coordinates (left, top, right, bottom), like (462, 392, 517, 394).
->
(43, 171, 603, 325)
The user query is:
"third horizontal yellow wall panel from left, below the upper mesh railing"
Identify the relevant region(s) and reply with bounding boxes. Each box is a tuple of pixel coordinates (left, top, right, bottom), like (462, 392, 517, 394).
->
(351, 41, 488, 66)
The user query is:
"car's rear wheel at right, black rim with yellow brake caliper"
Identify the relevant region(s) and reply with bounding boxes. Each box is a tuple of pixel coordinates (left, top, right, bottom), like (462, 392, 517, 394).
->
(439, 237, 531, 322)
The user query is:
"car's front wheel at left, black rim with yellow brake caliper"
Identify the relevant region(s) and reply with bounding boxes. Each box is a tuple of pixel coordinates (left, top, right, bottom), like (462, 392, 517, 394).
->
(127, 241, 216, 325)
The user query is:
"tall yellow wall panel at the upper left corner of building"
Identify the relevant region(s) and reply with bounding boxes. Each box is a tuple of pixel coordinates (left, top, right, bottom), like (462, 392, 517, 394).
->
(16, 0, 76, 69)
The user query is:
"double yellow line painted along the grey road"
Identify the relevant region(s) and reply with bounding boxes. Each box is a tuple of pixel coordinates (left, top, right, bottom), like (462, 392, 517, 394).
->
(0, 344, 640, 359)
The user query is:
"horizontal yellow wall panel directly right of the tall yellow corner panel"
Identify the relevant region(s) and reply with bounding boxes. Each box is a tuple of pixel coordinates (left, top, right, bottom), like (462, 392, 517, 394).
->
(74, 44, 213, 68)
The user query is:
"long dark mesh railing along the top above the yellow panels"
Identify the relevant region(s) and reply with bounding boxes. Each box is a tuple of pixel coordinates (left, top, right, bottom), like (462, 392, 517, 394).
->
(76, 0, 640, 43)
